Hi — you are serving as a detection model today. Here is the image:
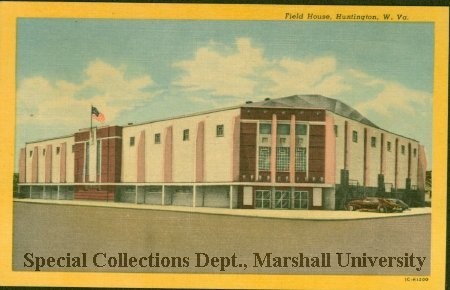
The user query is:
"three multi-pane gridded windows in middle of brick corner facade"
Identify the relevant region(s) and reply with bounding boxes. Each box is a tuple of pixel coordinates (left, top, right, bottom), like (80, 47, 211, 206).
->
(258, 146, 306, 172)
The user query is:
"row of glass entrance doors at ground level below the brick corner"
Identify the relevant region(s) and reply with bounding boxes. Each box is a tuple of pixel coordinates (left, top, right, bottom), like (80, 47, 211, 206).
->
(255, 190, 308, 209)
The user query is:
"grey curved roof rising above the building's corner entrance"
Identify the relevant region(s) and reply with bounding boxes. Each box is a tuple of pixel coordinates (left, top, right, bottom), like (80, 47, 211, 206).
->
(244, 95, 379, 128)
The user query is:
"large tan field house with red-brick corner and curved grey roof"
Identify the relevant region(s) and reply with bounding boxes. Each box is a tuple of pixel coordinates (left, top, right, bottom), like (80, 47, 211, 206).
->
(19, 95, 426, 209)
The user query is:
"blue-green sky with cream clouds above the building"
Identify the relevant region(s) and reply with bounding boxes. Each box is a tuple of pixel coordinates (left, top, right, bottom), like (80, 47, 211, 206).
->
(16, 19, 434, 167)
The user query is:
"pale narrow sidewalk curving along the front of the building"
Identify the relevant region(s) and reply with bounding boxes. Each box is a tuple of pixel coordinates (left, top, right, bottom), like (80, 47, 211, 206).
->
(14, 198, 431, 220)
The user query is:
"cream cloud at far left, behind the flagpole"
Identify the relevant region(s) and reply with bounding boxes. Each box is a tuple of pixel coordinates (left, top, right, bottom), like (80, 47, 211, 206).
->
(18, 59, 154, 128)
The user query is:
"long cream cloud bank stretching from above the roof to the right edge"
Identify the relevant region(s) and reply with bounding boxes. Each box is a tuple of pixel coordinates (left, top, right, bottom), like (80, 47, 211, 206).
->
(174, 38, 432, 130)
